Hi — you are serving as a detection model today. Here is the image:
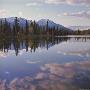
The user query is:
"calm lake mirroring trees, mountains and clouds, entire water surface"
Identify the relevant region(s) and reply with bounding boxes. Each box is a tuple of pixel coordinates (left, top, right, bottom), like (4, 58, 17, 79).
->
(0, 36, 90, 90)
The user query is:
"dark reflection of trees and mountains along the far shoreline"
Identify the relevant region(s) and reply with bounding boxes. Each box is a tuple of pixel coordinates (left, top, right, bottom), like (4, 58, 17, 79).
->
(0, 36, 90, 55)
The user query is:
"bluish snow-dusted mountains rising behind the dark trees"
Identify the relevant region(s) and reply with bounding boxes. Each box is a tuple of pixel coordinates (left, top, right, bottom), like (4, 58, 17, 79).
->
(0, 17, 70, 30)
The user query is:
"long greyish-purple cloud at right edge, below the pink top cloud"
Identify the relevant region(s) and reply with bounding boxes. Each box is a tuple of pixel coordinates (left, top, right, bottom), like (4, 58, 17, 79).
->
(63, 11, 90, 18)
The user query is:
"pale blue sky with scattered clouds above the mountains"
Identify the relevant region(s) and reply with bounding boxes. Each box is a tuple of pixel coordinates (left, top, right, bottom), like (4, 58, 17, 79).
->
(0, 0, 90, 26)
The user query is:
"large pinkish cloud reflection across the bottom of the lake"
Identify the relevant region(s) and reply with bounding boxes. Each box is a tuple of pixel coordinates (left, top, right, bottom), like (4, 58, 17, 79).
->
(0, 61, 90, 90)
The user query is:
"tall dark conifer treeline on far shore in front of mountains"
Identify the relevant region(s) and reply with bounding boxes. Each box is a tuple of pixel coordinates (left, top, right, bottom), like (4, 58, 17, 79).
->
(0, 17, 71, 36)
